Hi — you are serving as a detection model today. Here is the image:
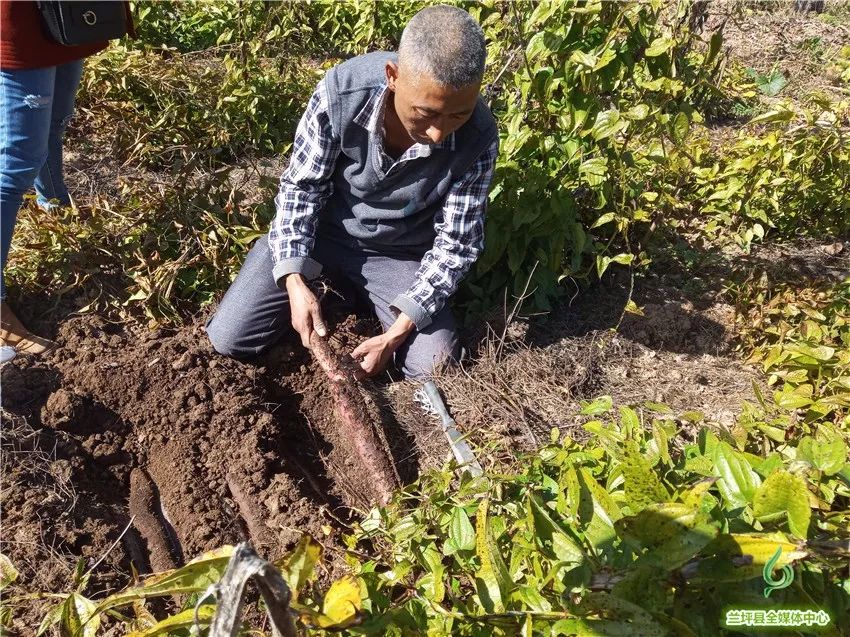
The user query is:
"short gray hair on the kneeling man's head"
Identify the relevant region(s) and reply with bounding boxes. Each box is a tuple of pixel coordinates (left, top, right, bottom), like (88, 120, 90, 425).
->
(398, 4, 487, 89)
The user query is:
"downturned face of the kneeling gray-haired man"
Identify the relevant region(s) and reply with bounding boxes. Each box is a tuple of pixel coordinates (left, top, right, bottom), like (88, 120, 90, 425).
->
(386, 62, 481, 144)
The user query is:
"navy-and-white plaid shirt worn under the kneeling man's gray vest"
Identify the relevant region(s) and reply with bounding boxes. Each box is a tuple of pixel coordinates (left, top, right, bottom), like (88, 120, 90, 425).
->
(269, 80, 499, 329)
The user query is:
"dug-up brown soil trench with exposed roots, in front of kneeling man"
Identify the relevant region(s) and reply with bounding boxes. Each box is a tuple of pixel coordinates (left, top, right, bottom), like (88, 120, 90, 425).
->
(2, 306, 398, 591)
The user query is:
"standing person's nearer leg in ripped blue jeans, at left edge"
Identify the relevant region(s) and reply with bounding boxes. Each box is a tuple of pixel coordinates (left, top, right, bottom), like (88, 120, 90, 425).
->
(0, 67, 56, 299)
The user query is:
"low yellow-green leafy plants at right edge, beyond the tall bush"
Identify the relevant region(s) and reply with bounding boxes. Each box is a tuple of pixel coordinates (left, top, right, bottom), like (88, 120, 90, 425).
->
(678, 102, 850, 247)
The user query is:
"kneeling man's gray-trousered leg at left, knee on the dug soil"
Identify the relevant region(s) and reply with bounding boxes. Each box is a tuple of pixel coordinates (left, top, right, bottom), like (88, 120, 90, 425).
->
(206, 236, 291, 358)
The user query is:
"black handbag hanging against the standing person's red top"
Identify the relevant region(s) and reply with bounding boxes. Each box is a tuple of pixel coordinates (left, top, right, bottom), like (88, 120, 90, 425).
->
(37, 0, 128, 46)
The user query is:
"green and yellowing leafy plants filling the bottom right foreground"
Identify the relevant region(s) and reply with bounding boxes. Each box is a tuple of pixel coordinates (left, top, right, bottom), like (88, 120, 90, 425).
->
(332, 401, 850, 636)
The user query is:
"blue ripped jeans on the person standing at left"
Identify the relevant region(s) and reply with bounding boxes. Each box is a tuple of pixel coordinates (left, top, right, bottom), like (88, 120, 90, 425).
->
(0, 60, 83, 298)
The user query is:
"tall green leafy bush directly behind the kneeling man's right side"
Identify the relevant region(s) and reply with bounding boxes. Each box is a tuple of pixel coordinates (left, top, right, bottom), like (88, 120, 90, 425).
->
(458, 2, 721, 313)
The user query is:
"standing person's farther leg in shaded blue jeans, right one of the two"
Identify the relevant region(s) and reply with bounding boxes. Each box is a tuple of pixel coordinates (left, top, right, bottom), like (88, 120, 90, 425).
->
(35, 60, 83, 210)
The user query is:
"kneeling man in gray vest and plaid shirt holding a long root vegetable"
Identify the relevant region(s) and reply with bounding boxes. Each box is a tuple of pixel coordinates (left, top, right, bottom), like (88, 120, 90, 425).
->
(207, 5, 498, 378)
